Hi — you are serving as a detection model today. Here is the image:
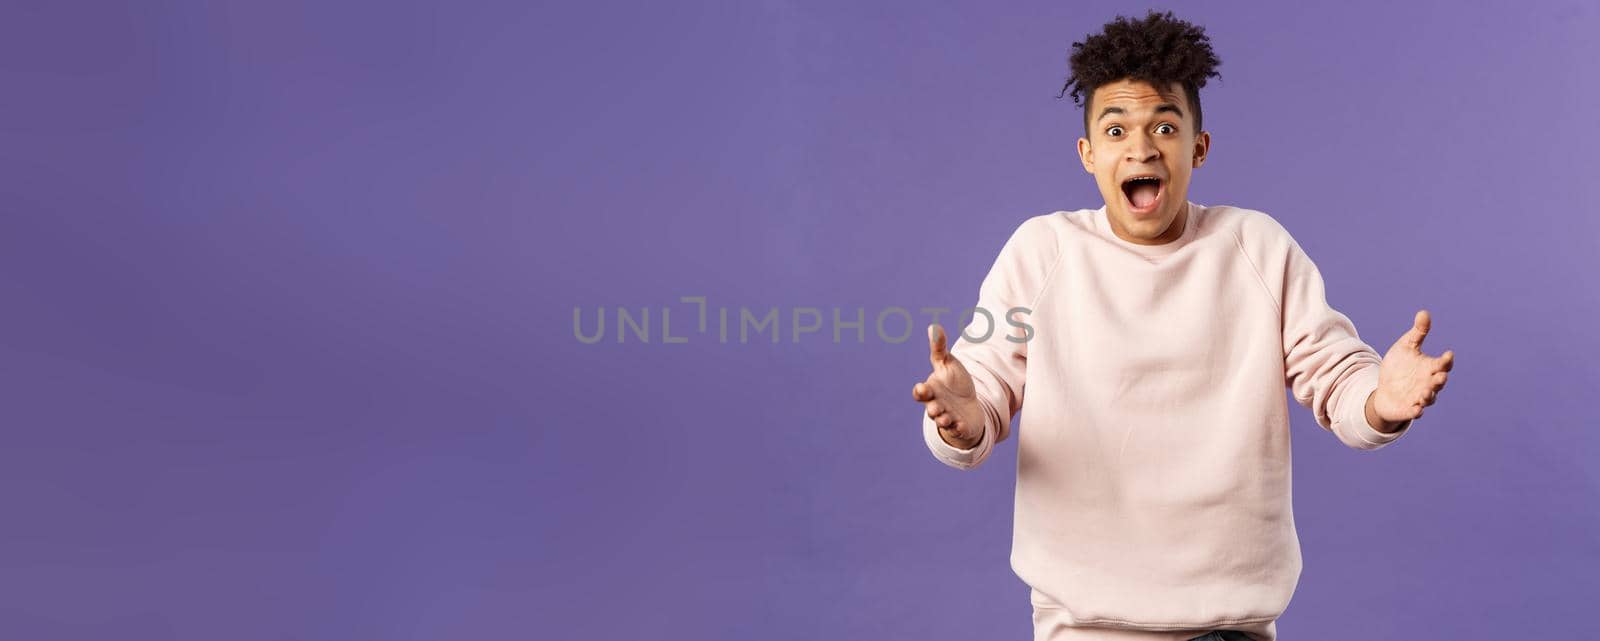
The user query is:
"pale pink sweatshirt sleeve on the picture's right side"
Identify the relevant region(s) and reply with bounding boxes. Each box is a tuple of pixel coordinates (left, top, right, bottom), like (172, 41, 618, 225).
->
(1278, 227, 1411, 449)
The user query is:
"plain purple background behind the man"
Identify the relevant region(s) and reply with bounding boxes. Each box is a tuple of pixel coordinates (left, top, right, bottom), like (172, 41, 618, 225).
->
(0, 0, 1600, 639)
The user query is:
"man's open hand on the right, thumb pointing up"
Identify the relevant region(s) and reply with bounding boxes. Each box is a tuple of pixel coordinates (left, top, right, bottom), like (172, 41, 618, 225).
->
(1366, 310, 1456, 432)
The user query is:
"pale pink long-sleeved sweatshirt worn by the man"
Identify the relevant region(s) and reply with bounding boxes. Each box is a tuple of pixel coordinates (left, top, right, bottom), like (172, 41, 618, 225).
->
(923, 203, 1411, 641)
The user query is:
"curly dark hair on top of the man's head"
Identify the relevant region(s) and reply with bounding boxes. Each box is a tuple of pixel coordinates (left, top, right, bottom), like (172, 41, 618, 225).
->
(1056, 10, 1222, 133)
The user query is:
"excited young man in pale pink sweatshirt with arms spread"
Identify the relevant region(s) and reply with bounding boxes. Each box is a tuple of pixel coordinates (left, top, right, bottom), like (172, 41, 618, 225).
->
(912, 13, 1454, 641)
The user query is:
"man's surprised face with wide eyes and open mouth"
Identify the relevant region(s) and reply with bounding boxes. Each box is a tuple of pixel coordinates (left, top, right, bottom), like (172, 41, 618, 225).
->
(1078, 80, 1211, 245)
